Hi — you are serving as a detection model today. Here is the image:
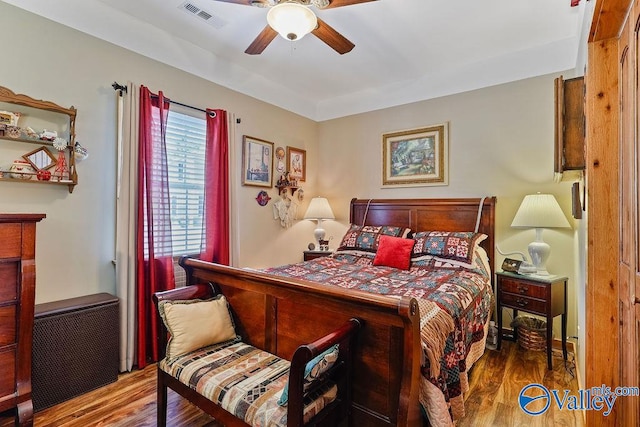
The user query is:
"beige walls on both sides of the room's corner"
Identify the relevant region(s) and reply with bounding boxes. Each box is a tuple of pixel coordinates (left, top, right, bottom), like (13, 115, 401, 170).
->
(0, 2, 583, 346)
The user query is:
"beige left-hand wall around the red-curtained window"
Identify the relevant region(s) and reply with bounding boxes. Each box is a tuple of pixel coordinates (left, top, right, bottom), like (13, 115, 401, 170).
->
(0, 2, 318, 303)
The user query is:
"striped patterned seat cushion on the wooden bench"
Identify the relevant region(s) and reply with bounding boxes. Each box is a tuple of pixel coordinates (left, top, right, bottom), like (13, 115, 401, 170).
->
(159, 340, 337, 427)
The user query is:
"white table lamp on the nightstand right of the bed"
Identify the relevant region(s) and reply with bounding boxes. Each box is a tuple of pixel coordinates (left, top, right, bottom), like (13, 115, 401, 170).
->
(511, 193, 570, 276)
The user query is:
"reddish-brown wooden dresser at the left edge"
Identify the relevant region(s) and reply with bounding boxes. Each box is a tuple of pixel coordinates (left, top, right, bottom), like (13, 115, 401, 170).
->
(0, 214, 45, 426)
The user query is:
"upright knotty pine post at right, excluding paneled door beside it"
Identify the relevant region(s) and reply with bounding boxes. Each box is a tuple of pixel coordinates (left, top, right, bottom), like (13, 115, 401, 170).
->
(585, 39, 621, 426)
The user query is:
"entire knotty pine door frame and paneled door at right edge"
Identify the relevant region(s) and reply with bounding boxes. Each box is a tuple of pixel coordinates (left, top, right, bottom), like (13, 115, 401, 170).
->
(584, 0, 640, 426)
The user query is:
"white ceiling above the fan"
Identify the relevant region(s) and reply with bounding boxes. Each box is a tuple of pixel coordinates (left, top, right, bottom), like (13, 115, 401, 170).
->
(4, 0, 595, 121)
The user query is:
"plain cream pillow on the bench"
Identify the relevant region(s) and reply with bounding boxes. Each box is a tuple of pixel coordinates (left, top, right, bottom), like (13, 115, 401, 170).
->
(158, 295, 236, 359)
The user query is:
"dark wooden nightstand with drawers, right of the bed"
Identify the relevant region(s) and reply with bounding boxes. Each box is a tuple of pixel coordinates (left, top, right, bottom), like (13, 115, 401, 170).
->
(496, 271, 568, 369)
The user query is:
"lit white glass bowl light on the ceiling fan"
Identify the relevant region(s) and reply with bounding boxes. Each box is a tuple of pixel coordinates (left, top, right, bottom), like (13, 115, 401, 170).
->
(267, 2, 318, 40)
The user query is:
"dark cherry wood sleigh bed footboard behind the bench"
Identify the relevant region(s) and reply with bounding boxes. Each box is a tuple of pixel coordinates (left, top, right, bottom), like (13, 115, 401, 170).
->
(180, 258, 422, 426)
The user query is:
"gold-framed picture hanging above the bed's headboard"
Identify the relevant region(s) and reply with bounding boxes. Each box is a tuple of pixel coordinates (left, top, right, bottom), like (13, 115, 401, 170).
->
(382, 123, 449, 187)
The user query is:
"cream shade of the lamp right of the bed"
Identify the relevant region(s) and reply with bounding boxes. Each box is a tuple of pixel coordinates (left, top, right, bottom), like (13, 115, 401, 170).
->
(511, 194, 570, 228)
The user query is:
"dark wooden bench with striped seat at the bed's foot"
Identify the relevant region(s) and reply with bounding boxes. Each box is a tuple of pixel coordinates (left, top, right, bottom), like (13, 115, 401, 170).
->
(154, 284, 360, 427)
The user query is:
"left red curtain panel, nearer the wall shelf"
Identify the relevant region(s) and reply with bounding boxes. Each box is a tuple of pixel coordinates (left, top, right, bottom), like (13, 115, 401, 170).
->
(136, 86, 175, 369)
